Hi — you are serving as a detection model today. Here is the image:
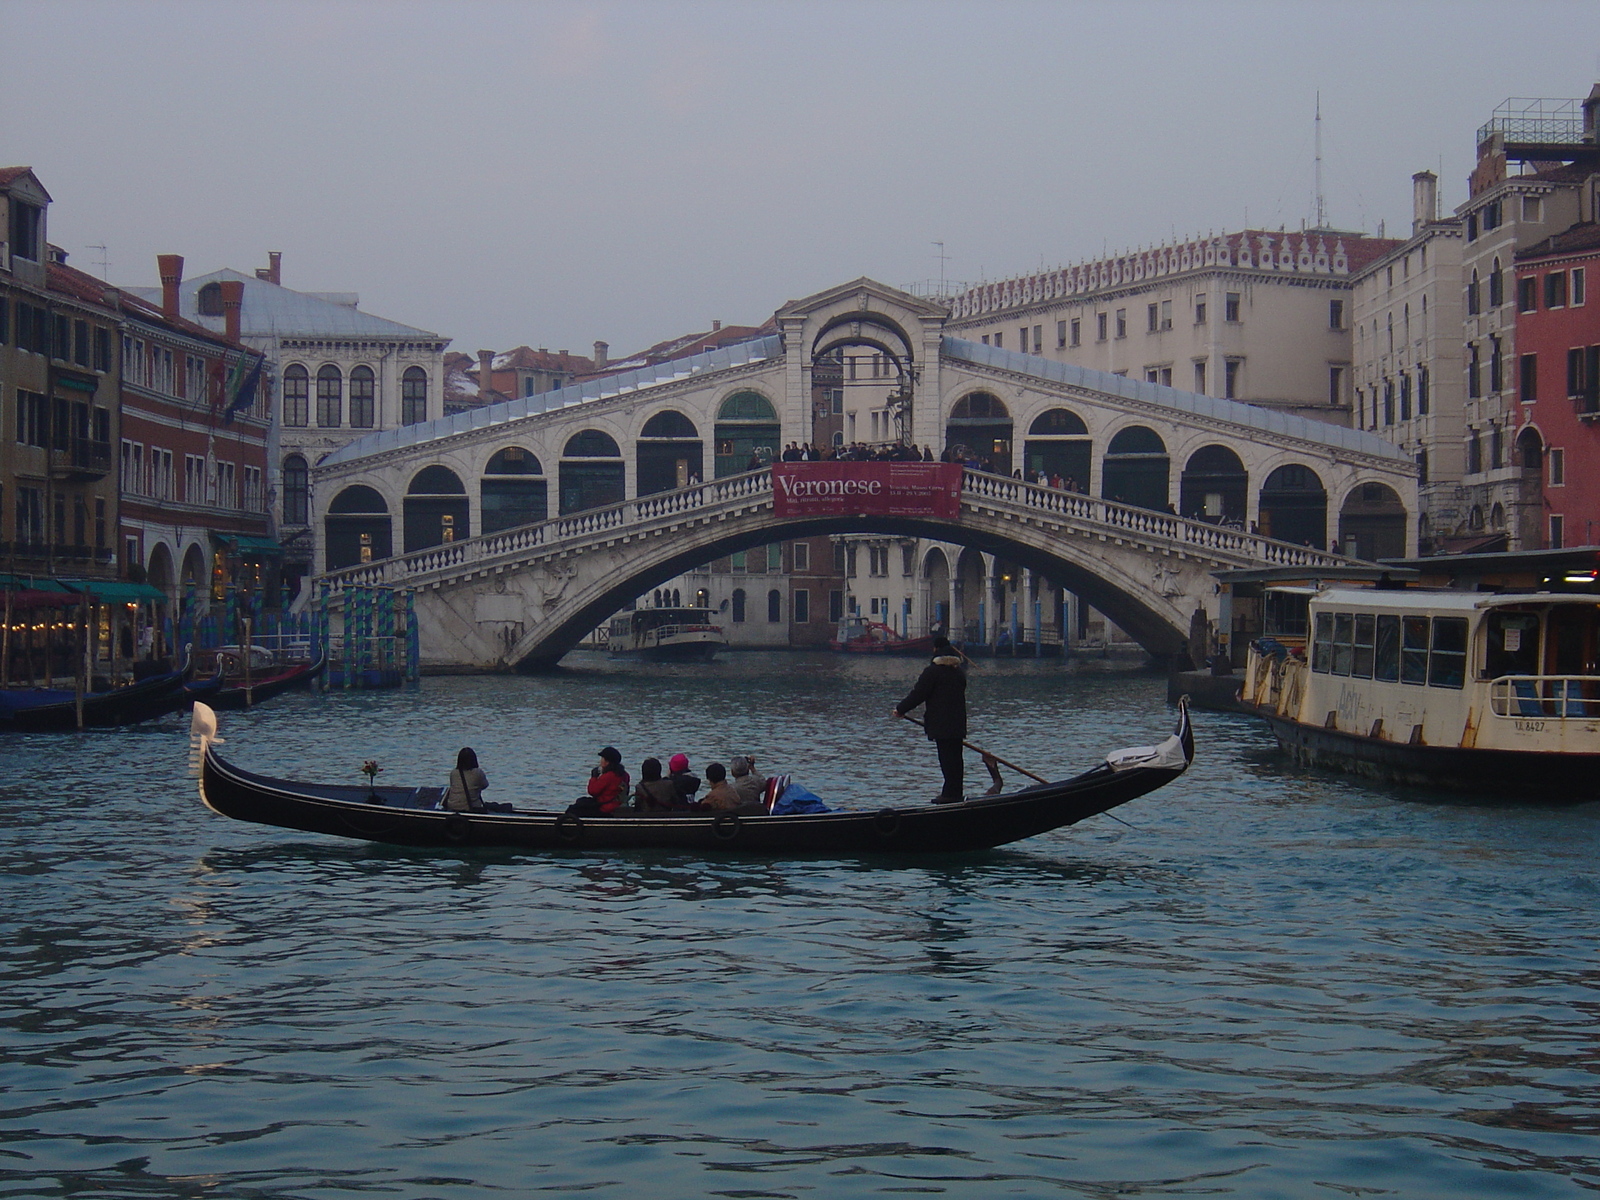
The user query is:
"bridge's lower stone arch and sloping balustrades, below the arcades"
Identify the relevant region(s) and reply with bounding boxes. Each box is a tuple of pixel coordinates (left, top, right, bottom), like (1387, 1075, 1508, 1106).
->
(323, 470, 1350, 670)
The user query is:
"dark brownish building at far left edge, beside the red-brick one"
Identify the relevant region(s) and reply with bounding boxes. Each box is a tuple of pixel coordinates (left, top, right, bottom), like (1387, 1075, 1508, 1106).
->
(0, 166, 120, 579)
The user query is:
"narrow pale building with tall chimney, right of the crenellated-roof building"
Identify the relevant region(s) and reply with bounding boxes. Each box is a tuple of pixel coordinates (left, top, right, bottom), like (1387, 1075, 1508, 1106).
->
(1350, 171, 1467, 552)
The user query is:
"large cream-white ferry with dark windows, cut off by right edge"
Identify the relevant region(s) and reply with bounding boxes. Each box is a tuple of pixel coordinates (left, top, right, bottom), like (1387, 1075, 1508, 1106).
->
(1240, 587, 1600, 803)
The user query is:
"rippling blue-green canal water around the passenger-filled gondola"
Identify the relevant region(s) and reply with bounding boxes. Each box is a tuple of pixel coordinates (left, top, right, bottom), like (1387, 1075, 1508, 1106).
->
(0, 654, 1600, 1200)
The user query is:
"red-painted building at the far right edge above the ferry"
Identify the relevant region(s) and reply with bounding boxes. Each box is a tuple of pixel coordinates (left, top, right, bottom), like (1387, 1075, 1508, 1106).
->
(1517, 221, 1600, 549)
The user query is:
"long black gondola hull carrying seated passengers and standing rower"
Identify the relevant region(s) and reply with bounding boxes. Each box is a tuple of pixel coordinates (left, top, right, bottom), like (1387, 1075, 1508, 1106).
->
(190, 698, 1194, 856)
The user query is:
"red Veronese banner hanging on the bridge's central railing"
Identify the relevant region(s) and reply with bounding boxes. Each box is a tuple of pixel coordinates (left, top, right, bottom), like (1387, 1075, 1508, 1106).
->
(773, 462, 962, 520)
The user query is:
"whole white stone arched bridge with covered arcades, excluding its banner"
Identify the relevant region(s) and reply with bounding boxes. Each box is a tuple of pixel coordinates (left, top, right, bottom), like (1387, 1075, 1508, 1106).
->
(310, 280, 1416, 669)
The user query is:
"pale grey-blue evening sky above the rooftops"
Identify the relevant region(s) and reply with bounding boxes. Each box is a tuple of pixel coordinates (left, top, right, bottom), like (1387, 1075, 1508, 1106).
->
(9, 0, 1600, 358)
